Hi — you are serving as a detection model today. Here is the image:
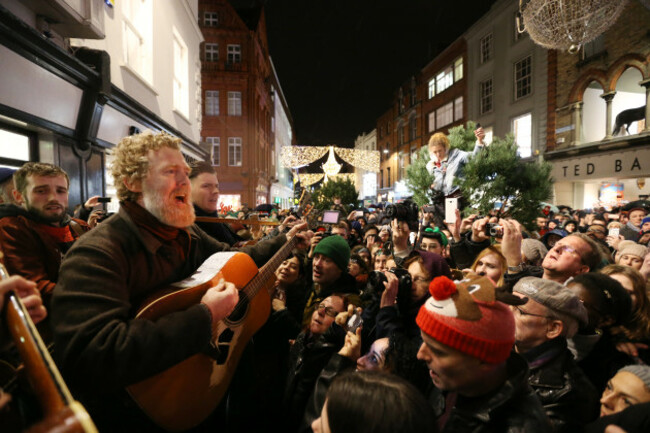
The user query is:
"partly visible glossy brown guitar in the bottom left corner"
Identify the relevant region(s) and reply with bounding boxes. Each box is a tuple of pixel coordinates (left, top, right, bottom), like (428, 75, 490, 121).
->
(0, 264, 97, 433)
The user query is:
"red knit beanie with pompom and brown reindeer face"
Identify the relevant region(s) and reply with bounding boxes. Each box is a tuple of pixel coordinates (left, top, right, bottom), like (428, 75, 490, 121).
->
(416, 276, 515, 364)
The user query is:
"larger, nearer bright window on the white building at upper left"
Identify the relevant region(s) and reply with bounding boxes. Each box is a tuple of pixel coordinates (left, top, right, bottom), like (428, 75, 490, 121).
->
(122, 0, 153, 83)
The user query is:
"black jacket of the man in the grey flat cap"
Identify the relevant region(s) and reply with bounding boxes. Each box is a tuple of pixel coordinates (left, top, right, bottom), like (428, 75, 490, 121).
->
(524, 337, 600, 433)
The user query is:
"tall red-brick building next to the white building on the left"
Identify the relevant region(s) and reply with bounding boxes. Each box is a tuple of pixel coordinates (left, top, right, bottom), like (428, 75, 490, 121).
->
(199, 0, 275, 207)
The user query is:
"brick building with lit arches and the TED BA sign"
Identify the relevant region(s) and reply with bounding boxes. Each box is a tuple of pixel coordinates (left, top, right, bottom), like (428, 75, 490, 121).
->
(545, 2, 650, 208)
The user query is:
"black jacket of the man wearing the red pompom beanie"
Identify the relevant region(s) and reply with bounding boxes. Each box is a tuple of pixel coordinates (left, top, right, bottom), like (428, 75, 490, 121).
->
(442, 353, 552, 433)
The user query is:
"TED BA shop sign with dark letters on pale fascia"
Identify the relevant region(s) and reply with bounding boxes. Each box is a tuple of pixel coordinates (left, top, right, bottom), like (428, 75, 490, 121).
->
(551, 148, 650, 181)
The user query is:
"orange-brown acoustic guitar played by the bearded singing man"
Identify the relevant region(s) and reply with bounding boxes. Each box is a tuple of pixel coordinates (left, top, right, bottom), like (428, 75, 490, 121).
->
(127, 236, 298, 431)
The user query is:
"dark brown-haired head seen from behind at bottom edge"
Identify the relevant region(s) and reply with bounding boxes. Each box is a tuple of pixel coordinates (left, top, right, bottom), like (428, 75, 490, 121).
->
(312, 371, 437, 433)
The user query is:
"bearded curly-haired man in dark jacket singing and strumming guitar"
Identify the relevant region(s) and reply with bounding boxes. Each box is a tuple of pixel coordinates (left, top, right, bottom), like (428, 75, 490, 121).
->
(51, 131, 311, 432)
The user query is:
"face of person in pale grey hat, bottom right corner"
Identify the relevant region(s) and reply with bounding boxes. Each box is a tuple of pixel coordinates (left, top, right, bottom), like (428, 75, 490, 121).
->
(600, 365, 650, 416)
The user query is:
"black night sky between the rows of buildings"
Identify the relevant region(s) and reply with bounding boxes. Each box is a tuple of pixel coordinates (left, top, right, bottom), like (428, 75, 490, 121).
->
(265, 0, 494, 147)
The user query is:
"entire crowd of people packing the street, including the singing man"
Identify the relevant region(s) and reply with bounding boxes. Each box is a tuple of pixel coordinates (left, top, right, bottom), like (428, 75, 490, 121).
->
(0, 128, 650, 433)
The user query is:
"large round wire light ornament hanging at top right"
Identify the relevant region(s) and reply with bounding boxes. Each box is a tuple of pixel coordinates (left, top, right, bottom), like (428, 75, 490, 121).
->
(517, 0, 628, 54)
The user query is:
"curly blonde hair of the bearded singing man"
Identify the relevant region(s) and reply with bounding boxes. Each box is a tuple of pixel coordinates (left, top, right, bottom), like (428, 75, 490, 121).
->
(111, 130, 181, 201)
